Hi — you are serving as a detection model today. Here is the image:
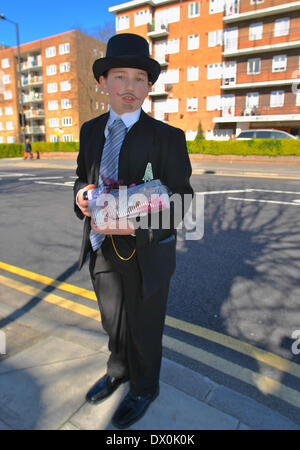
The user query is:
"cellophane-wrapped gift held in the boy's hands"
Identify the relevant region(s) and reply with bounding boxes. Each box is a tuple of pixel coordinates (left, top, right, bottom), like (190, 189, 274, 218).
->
(88, 180, 170, 226)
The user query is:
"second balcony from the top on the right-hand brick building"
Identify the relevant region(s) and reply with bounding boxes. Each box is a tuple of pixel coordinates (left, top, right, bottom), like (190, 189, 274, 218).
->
(222, 27, 300, 57)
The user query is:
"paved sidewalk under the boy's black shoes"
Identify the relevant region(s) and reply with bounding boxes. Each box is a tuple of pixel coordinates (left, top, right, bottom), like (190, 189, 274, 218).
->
(0, 303, 300, 431)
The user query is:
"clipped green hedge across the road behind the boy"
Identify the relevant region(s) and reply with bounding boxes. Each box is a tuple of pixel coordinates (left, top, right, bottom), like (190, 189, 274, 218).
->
(0, 139, 300, 158)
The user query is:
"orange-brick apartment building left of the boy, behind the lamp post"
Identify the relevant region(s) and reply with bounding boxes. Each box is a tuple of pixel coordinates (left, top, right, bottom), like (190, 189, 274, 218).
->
(0, 30, 108, 143)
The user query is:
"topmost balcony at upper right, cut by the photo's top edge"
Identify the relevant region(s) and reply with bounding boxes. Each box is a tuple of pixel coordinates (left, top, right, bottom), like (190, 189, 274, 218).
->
(223, 0, 300, 24)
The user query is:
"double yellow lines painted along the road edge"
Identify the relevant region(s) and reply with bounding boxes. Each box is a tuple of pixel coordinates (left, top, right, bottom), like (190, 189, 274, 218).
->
(0, 261, 300, 406)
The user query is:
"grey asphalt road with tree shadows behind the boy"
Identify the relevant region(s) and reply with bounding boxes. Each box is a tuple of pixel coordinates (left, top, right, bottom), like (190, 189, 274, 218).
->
(0, 167, 300, 423)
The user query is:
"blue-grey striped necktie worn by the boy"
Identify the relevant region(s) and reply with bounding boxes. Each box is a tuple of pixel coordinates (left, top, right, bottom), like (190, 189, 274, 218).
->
(90, 118, 127, 251)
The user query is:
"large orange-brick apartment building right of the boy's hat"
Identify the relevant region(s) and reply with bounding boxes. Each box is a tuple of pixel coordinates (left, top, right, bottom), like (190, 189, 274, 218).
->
(109, 0, 300, 139)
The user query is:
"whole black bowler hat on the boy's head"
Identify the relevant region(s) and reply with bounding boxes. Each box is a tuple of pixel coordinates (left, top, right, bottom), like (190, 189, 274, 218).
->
(93, 33, 161, 84)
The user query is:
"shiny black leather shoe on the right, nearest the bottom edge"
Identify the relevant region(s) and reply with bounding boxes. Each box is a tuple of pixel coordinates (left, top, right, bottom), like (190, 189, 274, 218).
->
(112, 390, 159, 428)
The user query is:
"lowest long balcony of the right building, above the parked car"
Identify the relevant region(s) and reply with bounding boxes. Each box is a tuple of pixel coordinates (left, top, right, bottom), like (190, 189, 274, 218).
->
(213, 105, 300, 125)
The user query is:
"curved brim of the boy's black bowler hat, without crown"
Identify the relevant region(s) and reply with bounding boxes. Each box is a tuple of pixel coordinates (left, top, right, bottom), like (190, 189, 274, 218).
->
(93, 56, 161, 84)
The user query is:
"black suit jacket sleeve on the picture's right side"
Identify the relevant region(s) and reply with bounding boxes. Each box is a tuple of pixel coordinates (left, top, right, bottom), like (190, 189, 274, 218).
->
(136, 127, 193, 247)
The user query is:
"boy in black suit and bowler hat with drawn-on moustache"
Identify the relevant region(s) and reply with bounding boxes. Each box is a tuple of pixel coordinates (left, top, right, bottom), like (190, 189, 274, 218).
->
(74, 33, 193, 428)
